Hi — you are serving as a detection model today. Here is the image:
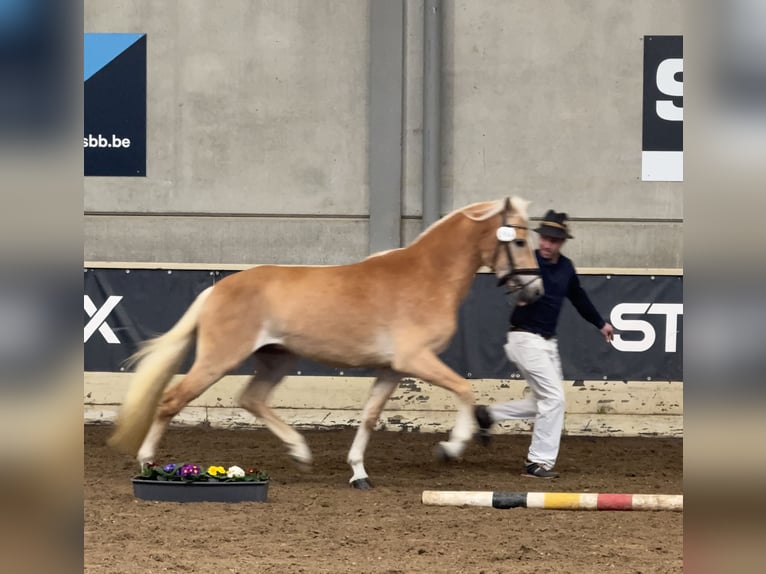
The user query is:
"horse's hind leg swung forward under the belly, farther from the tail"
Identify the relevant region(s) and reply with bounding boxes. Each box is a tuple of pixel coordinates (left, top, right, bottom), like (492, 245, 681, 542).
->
(239, 347, 312, 467)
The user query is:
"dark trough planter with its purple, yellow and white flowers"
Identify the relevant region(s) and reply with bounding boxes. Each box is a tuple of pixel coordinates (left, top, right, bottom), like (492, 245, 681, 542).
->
(132, 463, 269, 502)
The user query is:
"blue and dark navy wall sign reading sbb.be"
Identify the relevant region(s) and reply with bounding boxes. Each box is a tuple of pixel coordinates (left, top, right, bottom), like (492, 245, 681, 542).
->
(83, 34, 146, 176)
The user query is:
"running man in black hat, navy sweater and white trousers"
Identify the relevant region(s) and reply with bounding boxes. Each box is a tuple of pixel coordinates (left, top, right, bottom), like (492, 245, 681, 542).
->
(474, 209, 613, 478)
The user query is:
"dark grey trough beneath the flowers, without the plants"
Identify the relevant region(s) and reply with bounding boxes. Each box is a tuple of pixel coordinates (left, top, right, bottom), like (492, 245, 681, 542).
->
(133, 476, 269, 502)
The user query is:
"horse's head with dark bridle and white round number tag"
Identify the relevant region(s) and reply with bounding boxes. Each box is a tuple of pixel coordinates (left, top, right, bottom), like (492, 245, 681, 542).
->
(482, 197, 544, 305)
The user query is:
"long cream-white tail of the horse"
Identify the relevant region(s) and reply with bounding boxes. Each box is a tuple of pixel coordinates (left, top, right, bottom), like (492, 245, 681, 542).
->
(107, 287, 213, 456)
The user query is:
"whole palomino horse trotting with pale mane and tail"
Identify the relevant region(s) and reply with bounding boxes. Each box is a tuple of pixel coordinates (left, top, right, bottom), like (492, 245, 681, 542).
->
(109, 198, 543, 488)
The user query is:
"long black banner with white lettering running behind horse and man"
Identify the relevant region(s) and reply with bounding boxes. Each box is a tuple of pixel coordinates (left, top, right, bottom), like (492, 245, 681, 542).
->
(84, 269, 683, 381)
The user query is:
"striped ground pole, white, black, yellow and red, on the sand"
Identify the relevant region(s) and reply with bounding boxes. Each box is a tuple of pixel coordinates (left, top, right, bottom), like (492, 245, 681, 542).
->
(421, 490, 684, 512)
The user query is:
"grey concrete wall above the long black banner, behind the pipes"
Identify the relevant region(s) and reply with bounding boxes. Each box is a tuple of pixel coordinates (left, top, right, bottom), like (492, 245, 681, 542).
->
(84, 0, 683, 268)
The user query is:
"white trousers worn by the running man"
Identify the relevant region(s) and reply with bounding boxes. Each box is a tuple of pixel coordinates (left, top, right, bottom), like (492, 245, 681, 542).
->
(488, 331, 564, 468)
